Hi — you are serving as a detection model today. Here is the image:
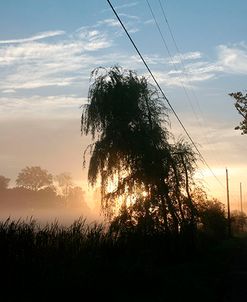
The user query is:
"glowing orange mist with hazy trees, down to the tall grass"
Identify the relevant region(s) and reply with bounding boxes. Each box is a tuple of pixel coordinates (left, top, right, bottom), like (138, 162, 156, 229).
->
(0, 170, 103, 225)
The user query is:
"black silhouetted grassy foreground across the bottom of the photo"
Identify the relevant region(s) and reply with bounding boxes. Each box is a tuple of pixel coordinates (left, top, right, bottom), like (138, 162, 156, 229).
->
(0, 219, 247, 302)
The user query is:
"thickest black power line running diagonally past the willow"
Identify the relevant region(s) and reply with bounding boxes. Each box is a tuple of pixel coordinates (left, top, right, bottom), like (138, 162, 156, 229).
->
(107, 0, 224, 187)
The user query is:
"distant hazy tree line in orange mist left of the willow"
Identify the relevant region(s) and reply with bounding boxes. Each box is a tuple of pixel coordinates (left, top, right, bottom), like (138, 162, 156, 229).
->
(0, 166, 88, 209)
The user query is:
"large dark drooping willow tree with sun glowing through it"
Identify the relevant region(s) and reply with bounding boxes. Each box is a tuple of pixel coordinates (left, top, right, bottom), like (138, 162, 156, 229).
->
(81, 66, 196, 232)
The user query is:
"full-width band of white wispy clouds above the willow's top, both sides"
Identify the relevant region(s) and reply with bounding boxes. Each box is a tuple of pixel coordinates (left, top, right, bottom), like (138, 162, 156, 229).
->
(0, 21, 247, 94)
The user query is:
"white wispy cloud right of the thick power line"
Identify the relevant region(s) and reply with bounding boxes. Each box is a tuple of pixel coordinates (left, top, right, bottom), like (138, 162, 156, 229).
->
(151, 43, 247, 87)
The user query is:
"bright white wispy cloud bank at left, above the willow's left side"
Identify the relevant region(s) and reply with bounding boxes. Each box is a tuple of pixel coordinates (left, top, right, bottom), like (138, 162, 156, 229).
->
(0, 28, 112, 93)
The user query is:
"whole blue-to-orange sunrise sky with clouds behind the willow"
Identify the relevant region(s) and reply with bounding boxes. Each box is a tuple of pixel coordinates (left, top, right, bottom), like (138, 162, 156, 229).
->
(0, 0, 247, 210)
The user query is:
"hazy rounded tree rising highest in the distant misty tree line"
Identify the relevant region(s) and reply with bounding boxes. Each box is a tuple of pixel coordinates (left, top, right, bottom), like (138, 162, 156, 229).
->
(16, 166, 52, 191)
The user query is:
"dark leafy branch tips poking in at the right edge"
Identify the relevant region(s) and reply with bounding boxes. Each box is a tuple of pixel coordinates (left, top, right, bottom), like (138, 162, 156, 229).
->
(229, 92, 247, 134)
